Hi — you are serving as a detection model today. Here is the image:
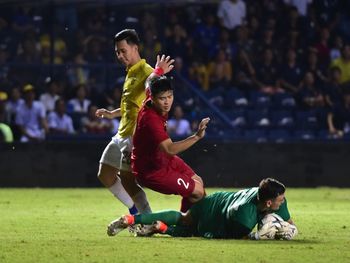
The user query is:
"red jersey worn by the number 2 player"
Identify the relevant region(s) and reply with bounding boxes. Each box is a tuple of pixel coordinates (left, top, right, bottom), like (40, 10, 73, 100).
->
(131, 99, 174, 176)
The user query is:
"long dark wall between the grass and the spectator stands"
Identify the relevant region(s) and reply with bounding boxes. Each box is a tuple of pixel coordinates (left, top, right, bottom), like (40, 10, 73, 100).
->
(0, 141, 350, 187)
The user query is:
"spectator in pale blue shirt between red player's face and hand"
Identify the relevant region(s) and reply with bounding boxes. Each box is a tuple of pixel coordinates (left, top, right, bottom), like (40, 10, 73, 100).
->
(167, 105, 192, 136)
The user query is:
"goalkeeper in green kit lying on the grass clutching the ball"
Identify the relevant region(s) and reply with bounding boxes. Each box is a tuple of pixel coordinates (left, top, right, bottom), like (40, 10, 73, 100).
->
(107, 178, 297, 239)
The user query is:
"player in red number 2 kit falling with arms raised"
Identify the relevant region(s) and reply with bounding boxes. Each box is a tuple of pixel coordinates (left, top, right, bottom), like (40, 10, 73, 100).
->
(131, 56, 210, 212)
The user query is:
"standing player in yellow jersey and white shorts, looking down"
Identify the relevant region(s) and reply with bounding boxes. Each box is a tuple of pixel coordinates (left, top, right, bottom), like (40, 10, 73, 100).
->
(96, 29, 153, 218)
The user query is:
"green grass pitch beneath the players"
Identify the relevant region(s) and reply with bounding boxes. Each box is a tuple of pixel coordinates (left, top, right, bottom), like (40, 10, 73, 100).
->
(0, 188, 350, 263)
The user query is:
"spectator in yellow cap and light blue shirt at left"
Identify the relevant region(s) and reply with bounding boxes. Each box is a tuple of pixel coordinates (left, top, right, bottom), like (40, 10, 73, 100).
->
(16, 84, 48, 142)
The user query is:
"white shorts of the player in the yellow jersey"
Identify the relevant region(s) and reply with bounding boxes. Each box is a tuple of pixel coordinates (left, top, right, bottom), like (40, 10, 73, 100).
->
(100, 135, 132, 171)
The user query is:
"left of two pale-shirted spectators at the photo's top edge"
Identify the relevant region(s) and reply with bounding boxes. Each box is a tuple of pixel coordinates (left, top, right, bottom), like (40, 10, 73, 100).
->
(217, 0, 246, 30)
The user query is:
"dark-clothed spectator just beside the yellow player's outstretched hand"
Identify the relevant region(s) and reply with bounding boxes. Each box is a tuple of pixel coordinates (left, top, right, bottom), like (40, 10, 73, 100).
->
(81, 105, 113, 134)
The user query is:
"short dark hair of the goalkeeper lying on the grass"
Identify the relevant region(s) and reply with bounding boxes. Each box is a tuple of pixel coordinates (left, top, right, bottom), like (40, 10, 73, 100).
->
(258, 178, 286, 201)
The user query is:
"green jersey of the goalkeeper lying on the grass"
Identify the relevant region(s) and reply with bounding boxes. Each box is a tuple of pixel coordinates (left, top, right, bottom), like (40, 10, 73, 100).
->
(190, 187, 290, 238)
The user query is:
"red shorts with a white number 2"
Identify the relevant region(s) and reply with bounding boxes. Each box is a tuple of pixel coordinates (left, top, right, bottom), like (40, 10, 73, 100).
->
(137, 156, 195, 197)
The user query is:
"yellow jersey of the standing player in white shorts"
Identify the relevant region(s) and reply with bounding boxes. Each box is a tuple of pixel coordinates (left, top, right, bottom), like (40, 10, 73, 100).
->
(118, 59, 153, 138)
